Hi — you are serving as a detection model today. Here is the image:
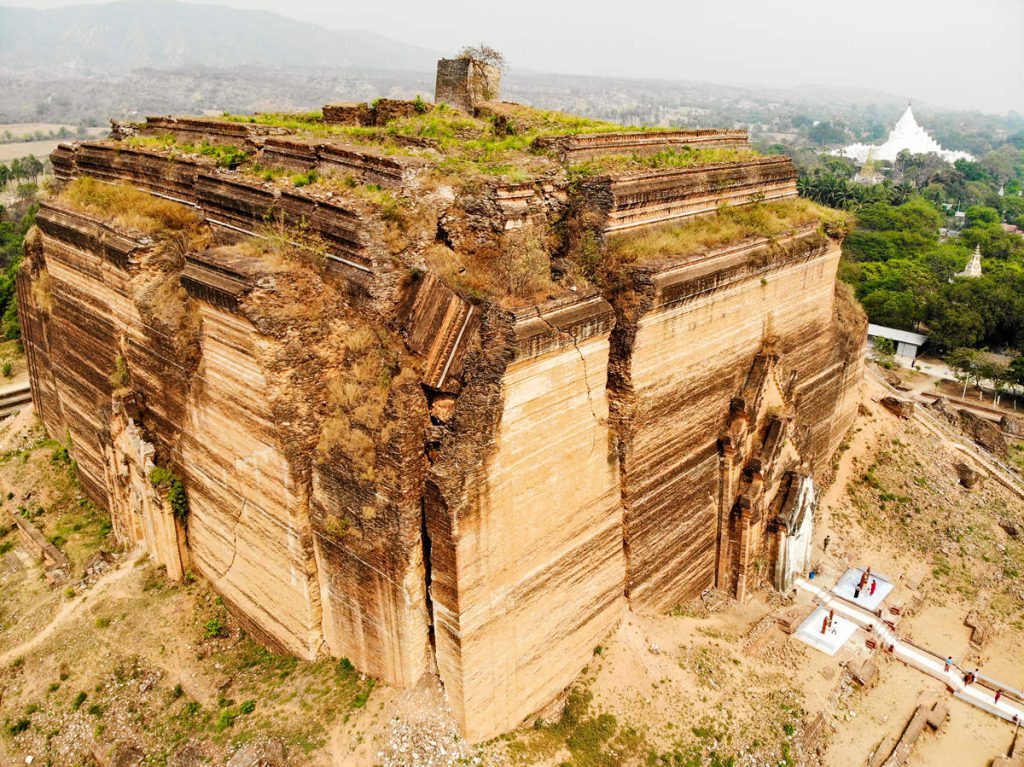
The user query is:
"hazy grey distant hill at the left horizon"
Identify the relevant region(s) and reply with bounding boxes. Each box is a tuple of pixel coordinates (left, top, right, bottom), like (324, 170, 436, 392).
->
(0, 0, 438, 76)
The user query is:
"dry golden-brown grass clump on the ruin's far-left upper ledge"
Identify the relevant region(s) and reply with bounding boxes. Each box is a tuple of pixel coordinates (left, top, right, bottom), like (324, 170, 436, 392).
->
(59, 176, 203, 235)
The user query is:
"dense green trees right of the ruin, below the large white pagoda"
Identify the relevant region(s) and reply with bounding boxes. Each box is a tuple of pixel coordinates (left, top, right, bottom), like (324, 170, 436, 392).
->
(798, 132, 1024, 383)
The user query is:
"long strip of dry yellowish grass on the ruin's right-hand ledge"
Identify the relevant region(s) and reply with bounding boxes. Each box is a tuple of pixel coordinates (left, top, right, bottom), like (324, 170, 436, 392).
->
(608, 198, 849, 263)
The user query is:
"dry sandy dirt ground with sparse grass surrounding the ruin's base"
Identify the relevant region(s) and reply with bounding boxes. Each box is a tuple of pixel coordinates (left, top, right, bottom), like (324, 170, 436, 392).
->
(0, 366, 1024, 767)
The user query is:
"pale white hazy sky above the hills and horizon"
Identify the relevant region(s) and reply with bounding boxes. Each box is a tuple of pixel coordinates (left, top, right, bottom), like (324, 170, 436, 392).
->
(8, 0, 1024, 114)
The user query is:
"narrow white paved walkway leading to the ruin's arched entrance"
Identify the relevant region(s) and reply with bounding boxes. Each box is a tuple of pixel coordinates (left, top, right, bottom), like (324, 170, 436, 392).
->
(797, 578, 1024, 722)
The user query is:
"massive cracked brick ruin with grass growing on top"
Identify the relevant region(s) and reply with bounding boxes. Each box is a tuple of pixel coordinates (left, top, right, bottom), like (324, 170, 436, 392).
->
(17, 59, 864, 740)
